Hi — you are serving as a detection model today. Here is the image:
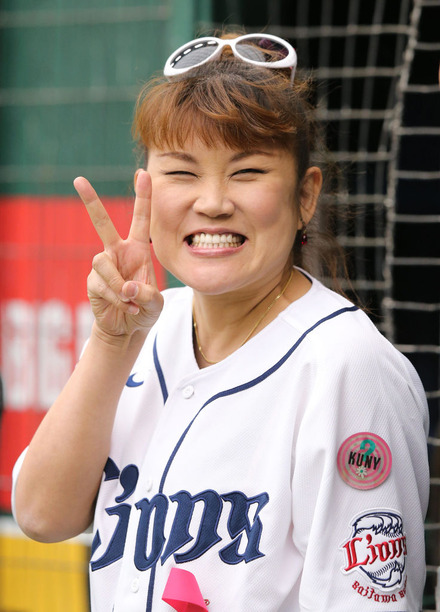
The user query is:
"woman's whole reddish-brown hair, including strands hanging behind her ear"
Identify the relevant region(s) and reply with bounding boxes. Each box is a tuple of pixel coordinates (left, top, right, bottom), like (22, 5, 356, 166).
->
(133, 33, 347, 291)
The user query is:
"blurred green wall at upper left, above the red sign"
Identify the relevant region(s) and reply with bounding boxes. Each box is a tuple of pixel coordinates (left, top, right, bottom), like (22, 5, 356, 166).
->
(0, 0, 211, 195)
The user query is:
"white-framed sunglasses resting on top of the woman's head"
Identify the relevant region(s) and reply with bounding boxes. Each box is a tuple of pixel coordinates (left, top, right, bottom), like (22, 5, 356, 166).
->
(163, 34, 297, 83)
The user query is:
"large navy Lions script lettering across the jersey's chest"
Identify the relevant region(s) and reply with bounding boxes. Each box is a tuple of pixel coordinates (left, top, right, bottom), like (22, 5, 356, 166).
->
(91, 460, 269, 571)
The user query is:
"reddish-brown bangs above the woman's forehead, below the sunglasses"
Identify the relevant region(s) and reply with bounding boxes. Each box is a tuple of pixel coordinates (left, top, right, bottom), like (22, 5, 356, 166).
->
(133, 61, 298, 150)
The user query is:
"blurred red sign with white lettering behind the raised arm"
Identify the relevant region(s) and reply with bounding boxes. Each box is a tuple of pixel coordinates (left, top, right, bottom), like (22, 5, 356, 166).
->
(0, 196, 165, 511)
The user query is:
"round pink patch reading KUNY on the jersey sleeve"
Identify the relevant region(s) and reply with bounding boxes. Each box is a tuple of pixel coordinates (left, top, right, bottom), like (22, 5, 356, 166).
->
(337, 431, 392, 490)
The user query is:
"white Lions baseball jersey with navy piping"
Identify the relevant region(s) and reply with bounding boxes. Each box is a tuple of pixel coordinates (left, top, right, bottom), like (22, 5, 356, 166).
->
(11, 272, 429, 612)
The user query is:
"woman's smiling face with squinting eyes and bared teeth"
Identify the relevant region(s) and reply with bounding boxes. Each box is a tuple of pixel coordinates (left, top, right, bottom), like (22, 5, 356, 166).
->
(147, 140, 318, 295)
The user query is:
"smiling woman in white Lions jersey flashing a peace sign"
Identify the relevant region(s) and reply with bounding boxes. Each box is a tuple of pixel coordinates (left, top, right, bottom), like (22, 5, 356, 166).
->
(15, 34, 429, 612)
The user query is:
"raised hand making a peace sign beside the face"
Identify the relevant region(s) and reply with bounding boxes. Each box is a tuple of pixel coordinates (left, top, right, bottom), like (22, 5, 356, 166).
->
(74, 170, 163, 336)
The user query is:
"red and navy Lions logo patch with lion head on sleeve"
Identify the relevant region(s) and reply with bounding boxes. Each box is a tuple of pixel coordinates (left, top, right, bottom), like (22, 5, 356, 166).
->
(340, 509, 407, 592)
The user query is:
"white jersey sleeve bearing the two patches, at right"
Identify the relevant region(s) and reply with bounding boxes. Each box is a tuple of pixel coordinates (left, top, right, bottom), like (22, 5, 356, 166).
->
(292, 322, 429, 612)
